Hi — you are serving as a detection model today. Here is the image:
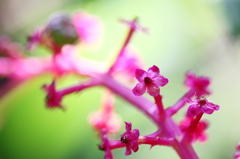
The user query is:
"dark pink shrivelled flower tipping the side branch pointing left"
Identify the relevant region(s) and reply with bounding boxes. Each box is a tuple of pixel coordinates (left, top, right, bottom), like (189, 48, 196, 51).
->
(43, 81, 63, 109)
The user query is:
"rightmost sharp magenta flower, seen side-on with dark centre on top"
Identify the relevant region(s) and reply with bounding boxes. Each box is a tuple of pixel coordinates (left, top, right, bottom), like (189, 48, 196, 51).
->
(187, 96, 220, 116)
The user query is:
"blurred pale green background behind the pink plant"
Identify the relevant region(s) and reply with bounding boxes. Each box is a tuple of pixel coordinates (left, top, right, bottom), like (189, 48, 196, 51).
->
(0, 0, 240, 159)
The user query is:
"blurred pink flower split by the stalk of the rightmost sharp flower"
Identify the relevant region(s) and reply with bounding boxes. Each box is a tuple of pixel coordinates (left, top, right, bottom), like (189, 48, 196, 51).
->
(179, 117, 208, 142)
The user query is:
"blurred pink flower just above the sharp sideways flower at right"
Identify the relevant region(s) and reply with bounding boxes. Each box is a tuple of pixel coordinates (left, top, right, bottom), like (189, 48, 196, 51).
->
(184, 71, 210, 97)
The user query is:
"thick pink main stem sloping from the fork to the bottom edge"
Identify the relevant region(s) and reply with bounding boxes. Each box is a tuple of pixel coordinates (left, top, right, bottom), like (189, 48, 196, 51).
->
(98, 74, 198, 159)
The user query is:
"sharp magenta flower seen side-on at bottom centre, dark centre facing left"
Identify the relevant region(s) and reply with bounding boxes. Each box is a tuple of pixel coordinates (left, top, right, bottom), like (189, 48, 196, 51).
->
(121, 122, 140, 156)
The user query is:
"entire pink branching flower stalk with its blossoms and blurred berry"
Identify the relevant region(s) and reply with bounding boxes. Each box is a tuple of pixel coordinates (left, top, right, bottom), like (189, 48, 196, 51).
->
(0, 11, 224, 159)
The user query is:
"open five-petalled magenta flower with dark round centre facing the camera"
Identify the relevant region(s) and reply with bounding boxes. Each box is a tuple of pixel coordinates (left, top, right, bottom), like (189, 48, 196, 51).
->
(132, 65, 168, 96)
